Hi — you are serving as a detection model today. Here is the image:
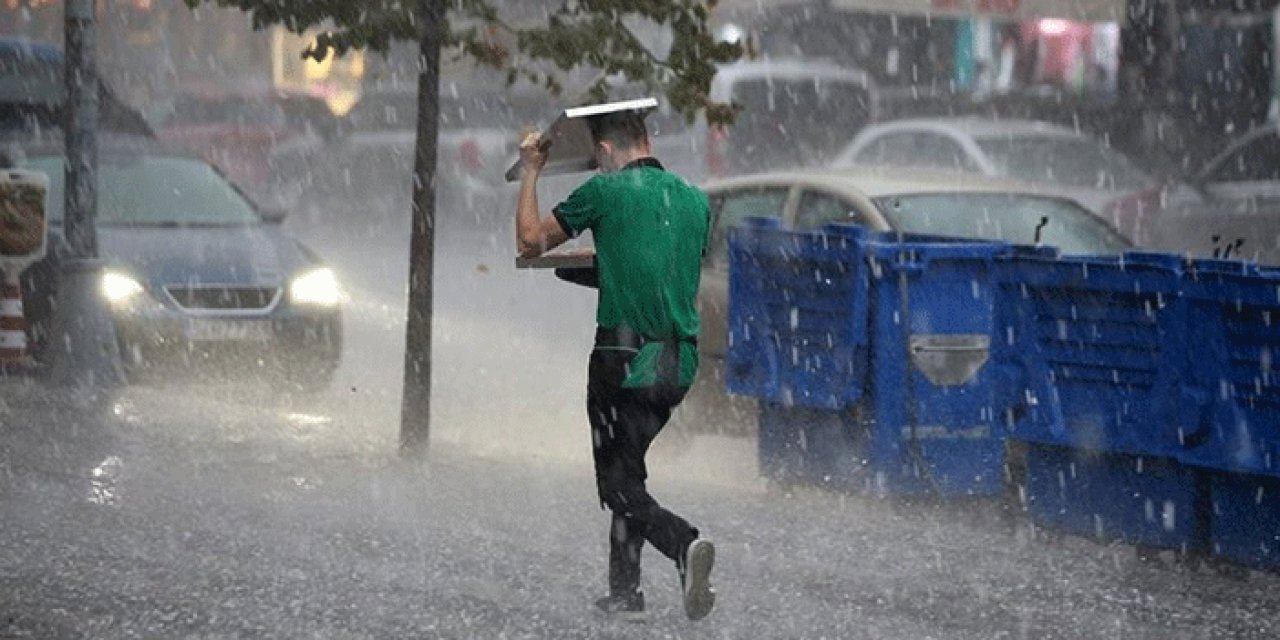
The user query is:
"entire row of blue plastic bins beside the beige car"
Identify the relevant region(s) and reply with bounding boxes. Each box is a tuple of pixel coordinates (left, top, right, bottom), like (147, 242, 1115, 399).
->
(727, 221, 1280, 568)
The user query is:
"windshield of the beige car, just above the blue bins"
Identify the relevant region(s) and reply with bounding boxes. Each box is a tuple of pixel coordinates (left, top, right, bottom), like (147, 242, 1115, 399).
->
(874, 193, 1129, 255)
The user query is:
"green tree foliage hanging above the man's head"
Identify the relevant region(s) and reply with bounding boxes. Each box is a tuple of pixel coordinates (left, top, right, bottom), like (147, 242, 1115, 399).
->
(186, 0, 742, 123)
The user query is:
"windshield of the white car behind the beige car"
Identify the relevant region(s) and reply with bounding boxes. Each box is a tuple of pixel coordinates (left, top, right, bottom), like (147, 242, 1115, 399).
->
(977, 136, 1151, 191)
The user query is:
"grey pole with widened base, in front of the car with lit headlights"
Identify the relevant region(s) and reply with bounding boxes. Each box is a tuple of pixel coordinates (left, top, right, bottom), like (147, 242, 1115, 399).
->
(49, 0, 124, 390)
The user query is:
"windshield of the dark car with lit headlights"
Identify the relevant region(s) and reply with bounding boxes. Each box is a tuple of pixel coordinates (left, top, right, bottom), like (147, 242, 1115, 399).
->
(26, 154, 261, 227)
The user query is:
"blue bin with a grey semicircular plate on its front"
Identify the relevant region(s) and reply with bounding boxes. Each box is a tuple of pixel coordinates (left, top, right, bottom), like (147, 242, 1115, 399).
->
(865, 236, 1011, 495)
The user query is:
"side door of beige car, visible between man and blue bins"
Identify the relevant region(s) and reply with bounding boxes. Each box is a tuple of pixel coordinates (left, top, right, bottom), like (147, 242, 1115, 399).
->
(698, 184, 792, 358)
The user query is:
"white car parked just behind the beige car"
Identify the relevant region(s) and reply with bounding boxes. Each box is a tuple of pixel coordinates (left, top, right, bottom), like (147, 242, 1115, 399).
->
(835, 118, 1158, 214)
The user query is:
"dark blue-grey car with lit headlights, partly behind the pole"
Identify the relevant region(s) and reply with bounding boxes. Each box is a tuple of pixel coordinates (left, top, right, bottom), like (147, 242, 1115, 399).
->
(17, 137, 342, 390)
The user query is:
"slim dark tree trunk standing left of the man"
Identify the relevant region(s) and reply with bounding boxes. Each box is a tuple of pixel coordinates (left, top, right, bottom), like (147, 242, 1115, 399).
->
(401, 0, 444, 456)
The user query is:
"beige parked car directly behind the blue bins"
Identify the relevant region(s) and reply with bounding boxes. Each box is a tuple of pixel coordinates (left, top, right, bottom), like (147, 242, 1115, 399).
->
(685, 168, 1132, 431)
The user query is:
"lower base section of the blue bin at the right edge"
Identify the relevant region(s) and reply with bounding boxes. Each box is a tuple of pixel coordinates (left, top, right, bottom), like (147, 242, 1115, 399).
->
(1210, 472, 1280, 571)
